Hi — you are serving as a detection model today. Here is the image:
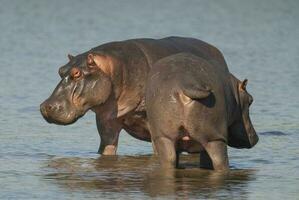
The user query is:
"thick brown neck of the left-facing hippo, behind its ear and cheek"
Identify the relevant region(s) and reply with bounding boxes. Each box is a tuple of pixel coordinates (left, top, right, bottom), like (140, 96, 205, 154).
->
(97, 42, 149, 117)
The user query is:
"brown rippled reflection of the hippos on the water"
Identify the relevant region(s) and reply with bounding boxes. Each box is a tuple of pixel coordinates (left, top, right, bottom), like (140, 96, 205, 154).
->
(45, 155, 255, 199)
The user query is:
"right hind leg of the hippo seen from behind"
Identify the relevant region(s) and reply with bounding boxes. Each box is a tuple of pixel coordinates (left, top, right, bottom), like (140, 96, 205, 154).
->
(201, 140, 229, 170)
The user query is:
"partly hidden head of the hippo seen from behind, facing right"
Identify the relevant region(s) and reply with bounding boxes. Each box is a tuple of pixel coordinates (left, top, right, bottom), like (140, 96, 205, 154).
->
(228, 79, 258, 148)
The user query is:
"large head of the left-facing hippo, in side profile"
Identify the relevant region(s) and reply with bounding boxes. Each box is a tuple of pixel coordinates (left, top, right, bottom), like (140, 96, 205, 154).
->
(40, 53, 112, 125)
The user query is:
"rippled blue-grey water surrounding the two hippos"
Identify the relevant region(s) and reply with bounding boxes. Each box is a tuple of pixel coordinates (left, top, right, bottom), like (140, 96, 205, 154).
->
(0, 0, 299, 199)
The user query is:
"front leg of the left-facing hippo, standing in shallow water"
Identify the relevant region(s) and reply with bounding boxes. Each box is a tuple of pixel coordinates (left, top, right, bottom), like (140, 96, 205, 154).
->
(97, 117, 122, 155)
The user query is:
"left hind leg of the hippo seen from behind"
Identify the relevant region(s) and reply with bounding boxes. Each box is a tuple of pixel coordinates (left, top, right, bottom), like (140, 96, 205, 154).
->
(153, 137, 177, 168)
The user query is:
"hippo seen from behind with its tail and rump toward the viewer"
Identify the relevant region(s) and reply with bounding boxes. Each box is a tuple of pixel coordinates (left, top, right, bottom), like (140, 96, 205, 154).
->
(146, 53, 258, 170)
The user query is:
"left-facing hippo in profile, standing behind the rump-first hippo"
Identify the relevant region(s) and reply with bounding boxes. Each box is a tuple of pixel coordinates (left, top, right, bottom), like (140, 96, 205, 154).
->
(40, 37, 258, 155)
